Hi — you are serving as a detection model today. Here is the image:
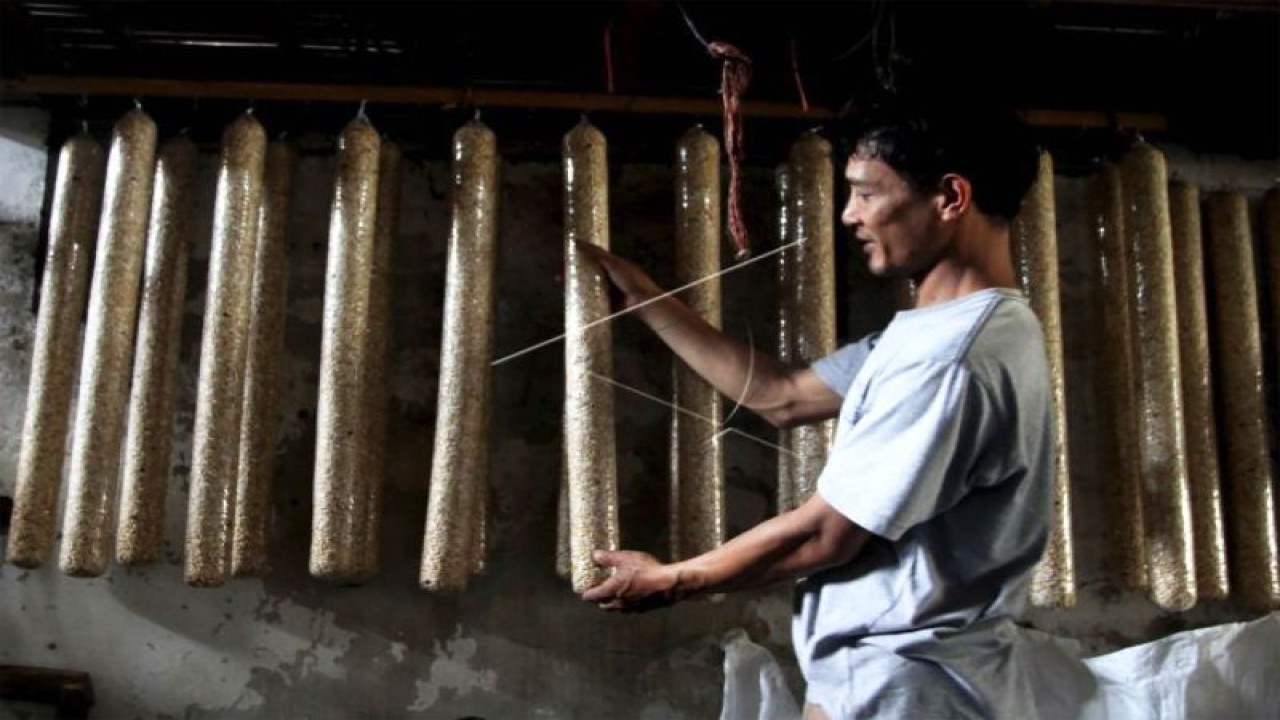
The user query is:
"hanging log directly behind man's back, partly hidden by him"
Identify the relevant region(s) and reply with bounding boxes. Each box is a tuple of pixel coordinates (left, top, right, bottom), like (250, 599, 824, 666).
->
(1012, 152, 1075, 607)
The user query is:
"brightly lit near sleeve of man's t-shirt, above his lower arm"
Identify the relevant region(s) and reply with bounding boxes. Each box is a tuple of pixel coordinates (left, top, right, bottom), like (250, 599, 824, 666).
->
(818, 361, 989, 541)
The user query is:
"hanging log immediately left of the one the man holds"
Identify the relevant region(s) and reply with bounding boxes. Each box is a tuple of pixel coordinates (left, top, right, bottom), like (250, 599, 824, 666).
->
(419, 120, 500, 591)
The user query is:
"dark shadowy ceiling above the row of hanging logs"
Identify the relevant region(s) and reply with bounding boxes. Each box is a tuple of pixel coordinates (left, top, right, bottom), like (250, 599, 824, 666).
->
(0, 0, 1280, 163)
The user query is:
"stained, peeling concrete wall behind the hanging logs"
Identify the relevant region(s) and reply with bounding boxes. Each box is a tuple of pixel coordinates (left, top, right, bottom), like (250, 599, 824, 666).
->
(0, 109, 1276, 720)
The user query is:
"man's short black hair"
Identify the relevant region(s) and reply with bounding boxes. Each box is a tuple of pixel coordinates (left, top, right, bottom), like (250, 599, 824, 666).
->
(842, 100, 1039, 220)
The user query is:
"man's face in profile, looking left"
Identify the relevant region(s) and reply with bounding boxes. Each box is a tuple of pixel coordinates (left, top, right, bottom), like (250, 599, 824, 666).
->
(840, 154, 945, 277)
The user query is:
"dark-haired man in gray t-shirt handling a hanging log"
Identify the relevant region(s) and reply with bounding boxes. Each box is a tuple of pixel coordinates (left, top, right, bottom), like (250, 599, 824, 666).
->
(582, 102, 1052, 719)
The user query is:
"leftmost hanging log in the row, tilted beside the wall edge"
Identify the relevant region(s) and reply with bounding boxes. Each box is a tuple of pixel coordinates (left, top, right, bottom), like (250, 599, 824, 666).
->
(8, 133, 105, 568)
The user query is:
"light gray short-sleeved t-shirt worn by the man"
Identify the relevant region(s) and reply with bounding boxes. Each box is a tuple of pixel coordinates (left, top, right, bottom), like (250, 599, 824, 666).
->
(792, 290, 1052, 719)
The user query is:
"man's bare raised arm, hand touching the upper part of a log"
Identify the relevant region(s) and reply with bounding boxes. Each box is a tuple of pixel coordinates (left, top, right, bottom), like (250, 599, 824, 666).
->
(579, 243, 841, 427)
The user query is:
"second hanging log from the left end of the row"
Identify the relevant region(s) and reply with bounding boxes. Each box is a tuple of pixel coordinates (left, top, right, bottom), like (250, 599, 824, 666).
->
(59, 109, 156, 577)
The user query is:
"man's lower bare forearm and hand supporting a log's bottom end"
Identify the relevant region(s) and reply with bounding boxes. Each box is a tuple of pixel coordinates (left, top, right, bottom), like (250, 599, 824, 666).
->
(582, 495, 870, 611)
